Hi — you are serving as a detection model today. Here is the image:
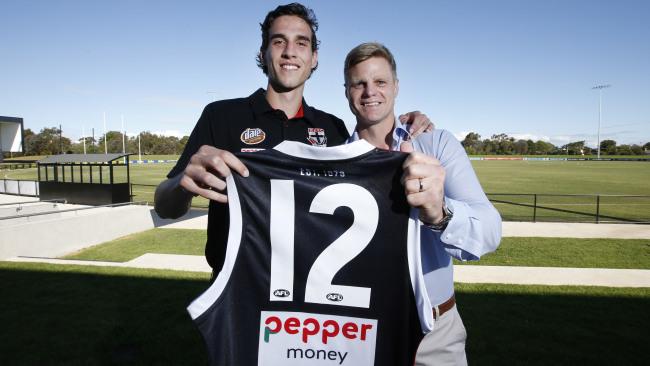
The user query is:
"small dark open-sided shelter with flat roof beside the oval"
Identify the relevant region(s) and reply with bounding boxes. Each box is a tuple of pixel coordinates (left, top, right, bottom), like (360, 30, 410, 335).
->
(38, 154, 131, 205)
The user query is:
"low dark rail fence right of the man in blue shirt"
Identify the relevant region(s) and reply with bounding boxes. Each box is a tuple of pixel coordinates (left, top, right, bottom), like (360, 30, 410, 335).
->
(487, 193, 650, 223)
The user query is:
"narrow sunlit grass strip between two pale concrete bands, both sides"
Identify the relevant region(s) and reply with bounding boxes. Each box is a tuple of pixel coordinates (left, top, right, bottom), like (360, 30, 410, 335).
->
(65, 229, 650, 269)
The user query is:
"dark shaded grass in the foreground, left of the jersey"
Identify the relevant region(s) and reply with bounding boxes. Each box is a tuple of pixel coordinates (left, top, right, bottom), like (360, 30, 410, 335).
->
(0, 268, 207, 365)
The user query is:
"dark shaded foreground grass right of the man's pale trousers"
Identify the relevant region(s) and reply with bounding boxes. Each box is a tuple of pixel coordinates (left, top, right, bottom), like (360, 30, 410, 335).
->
(456, 284, 650, 365)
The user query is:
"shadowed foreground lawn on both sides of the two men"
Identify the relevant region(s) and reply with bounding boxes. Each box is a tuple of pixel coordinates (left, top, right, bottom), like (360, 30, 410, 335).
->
(0, 264, 650, 365)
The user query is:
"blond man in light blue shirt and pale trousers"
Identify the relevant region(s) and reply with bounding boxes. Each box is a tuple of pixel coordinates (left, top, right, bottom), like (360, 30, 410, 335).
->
(344, 43, 501, 365)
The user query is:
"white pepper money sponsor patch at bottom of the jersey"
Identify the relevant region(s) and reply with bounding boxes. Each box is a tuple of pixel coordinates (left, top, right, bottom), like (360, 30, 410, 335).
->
(258, 311, 377, 366)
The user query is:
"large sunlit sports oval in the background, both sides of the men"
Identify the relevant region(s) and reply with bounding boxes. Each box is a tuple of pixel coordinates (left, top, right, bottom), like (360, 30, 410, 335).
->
(0, 160, 650, 222)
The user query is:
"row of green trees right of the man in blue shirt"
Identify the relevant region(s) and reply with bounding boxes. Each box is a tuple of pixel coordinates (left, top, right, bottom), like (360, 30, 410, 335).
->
(461, 132, 650, 155)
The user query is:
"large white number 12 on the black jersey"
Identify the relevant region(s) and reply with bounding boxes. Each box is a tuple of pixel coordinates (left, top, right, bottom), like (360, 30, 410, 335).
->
(270, 179, 379, 308)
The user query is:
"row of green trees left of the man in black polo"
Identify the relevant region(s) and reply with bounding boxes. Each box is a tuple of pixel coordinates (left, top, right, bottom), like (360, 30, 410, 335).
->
(23, 127, 189, 156)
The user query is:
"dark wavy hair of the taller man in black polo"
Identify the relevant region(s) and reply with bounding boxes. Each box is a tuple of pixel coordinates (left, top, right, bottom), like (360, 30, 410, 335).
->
(256, 3, 319, 74)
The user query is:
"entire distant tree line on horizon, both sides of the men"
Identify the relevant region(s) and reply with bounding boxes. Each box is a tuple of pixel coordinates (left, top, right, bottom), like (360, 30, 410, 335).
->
(8, 127, 650, 156)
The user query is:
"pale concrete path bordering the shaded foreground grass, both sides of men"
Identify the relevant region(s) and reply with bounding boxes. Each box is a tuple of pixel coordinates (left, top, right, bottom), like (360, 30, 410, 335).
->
(8, 253, 650, 287)
